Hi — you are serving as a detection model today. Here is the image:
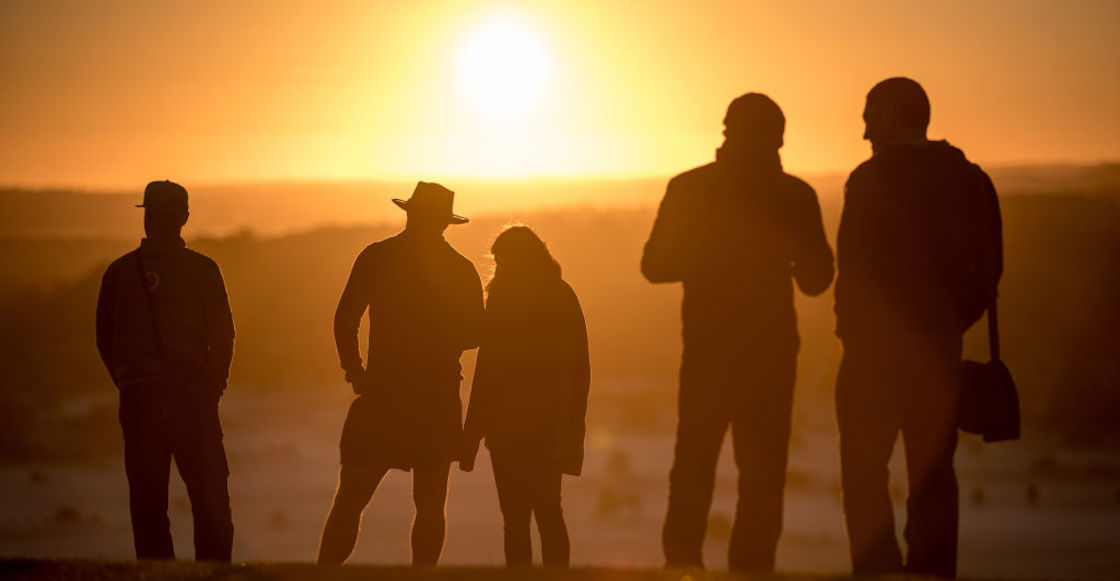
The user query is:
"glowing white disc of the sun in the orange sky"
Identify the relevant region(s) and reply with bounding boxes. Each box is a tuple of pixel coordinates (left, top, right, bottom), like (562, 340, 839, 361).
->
(458, 16, 549, 116)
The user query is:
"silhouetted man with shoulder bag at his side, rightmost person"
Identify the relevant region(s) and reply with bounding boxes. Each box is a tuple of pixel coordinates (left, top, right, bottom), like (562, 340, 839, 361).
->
(836, 78, 1002, 577)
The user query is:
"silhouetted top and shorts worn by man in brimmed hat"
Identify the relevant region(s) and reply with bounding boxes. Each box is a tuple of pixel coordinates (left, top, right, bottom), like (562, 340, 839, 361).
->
(335, 229, 483, 468)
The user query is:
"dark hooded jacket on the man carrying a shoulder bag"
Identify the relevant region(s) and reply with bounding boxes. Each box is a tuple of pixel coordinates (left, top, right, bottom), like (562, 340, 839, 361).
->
(836, 141, 1004, 339)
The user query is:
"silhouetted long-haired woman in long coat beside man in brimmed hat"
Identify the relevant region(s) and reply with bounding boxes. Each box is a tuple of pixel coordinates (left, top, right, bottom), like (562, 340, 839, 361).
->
(459, 226, 591, 566)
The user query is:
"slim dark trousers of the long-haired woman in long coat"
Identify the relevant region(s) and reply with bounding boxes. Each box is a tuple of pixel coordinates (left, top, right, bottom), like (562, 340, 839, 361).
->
(491, 451, 571, 568)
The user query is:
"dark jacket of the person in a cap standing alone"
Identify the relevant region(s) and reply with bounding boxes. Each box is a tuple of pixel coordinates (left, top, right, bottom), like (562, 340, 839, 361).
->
(96, 238, 234, 391)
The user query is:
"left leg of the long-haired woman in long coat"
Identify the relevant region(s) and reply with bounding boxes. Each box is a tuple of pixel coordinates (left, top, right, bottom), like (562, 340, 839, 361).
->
(491, 451, 543, 566)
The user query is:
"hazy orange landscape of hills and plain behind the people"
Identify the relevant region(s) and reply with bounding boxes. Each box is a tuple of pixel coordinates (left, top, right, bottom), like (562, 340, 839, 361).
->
(0, 165, 1120, 579)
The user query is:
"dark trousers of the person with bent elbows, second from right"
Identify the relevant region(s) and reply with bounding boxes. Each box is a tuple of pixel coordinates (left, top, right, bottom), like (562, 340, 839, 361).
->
(662, 346, 797, 571)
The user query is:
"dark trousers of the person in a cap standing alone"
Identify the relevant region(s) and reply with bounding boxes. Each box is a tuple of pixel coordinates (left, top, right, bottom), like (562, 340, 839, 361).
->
(119, 386, 233, 562)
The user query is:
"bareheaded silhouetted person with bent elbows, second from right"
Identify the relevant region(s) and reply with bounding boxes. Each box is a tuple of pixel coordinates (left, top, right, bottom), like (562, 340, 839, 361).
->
(642, 93, 833, 571)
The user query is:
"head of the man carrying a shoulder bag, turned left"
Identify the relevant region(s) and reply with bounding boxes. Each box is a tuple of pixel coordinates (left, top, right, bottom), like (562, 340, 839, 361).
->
(864, 77, 930, 151)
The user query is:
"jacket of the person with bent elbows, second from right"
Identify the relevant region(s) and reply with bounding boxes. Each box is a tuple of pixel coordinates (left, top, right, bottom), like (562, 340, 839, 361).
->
(642, 144, 833, 353)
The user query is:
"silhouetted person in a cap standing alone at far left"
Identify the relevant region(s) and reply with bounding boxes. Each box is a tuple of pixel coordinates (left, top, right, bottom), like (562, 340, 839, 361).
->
(97, 181, 233, 561)
